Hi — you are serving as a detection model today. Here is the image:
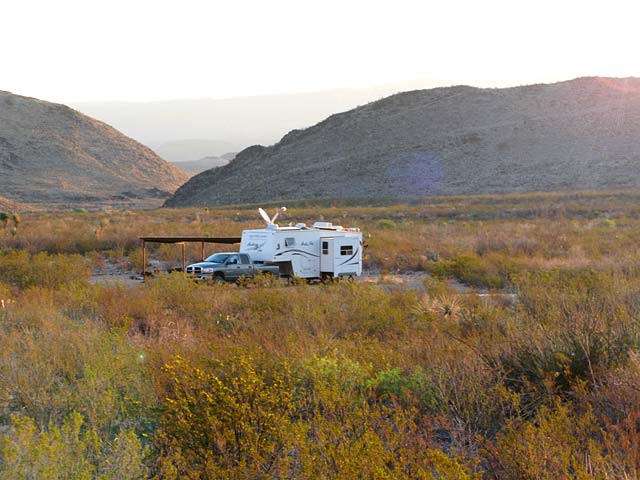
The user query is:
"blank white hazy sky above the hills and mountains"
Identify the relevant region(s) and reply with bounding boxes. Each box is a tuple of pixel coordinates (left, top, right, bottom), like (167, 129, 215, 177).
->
(5, 0, 640, 102)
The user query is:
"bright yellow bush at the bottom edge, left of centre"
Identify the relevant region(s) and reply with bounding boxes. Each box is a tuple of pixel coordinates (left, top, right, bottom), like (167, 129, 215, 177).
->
(159, 357, 294, 478)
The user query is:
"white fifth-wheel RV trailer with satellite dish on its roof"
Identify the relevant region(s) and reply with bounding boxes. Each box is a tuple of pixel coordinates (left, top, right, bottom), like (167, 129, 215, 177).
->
(240, 207, 363, 279)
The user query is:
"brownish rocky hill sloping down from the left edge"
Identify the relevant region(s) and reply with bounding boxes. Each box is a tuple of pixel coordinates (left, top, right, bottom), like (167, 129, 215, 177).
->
(0, 92, 188, 208)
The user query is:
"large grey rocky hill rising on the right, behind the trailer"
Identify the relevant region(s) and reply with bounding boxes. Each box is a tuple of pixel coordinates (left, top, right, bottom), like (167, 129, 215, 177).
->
(165, 77, 640, 206)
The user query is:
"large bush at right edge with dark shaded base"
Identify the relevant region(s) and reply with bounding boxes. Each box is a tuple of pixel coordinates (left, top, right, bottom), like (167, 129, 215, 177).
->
(492, 269, 640, 412)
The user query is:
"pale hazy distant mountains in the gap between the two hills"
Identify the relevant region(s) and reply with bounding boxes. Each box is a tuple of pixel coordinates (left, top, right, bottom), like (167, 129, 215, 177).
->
(70, 78, 443, 152)
